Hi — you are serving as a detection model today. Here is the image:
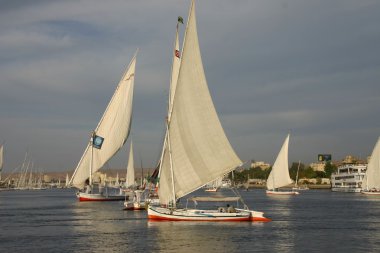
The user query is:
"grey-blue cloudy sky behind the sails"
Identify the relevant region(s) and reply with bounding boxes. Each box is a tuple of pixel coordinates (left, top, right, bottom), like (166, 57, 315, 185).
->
(0, 0, 380, 172)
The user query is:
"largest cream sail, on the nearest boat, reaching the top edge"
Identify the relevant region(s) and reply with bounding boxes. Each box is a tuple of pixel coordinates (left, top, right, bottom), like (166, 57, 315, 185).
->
(158, 2, 241, 204)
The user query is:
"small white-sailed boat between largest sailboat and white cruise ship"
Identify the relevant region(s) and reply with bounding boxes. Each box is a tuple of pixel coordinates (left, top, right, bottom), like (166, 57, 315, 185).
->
(266, 134, 299, 195)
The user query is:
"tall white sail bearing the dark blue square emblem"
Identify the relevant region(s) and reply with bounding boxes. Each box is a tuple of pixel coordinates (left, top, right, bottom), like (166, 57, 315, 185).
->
(70, 55, 136, 188)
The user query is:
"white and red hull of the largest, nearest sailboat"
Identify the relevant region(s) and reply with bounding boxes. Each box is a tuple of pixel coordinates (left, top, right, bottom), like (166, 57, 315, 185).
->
(148, 206, 271, 222)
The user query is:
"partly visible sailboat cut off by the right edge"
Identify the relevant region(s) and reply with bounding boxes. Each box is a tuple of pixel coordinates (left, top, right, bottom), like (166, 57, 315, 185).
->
(361, 138, 380, 195)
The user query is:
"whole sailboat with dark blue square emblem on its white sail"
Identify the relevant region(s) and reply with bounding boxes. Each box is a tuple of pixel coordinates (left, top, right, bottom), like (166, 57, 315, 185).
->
(70, 52, 137, 201)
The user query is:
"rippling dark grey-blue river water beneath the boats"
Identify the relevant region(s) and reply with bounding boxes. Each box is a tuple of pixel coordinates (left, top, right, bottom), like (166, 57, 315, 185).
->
(0, 189, 380, 253)
